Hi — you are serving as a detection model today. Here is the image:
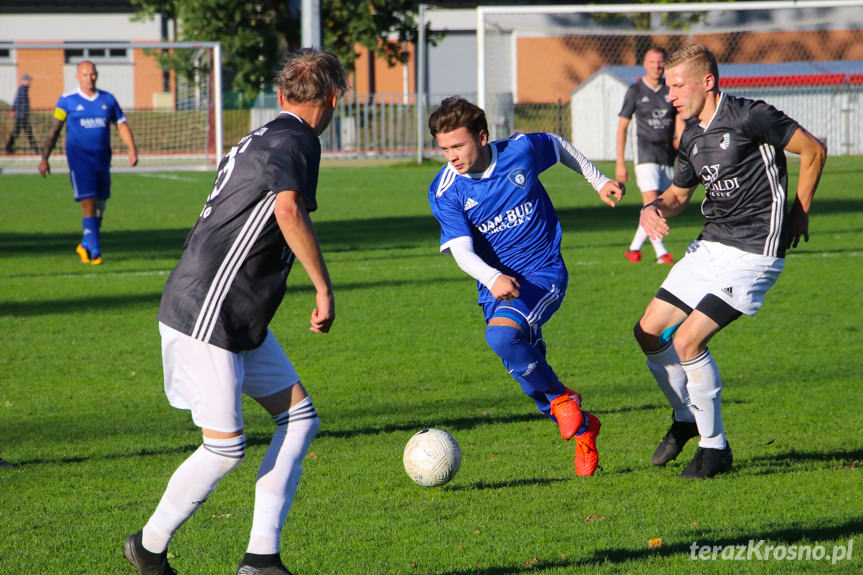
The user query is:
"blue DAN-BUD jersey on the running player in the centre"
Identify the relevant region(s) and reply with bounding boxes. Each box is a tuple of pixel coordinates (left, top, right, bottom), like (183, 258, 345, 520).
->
(429, 133, 564, 303)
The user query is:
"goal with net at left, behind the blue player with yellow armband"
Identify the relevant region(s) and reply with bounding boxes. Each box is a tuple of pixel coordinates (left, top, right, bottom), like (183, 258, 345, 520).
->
(0, 42, 222, 173)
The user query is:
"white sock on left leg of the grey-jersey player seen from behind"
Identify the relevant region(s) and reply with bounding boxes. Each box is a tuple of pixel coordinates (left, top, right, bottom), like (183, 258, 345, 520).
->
(142, 435, 246, 553)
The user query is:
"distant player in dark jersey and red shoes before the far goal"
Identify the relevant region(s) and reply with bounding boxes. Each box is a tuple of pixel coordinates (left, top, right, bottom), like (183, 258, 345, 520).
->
(614, 46, 683, 264)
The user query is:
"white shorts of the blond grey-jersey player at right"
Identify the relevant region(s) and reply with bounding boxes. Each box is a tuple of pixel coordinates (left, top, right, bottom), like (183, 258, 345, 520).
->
(662, 240, 785, 315)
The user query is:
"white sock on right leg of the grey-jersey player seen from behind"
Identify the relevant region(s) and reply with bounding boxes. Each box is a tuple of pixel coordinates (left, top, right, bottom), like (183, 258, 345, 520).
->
(246, 397, 321, 555)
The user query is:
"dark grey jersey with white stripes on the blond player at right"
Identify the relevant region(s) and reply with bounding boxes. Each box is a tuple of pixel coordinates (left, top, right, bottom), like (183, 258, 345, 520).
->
(674, 94, 800, 257)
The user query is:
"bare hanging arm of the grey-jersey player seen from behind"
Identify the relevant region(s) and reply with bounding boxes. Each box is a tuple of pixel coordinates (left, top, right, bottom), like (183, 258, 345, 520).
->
(275, 190, 336, 333)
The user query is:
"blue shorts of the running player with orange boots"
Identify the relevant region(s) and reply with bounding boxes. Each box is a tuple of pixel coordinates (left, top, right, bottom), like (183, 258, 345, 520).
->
(481, 266, 569, 343)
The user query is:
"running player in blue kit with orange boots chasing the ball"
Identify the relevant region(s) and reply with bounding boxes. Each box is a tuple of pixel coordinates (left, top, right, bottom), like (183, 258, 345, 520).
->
(429, 97, 624, 476)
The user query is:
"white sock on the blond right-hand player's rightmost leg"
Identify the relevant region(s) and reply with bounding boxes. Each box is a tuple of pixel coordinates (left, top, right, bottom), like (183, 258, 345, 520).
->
(681, 349, 726, 449)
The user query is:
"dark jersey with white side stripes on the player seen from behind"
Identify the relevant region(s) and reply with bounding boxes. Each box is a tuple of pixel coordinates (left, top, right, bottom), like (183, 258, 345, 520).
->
(159, 112, 321, 352)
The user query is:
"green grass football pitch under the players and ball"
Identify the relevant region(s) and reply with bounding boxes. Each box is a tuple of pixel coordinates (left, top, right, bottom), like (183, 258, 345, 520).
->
(0, 158, 863, 575)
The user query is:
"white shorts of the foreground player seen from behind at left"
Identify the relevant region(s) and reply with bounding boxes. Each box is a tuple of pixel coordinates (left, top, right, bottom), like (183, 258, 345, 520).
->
(159, 322, 300, 433)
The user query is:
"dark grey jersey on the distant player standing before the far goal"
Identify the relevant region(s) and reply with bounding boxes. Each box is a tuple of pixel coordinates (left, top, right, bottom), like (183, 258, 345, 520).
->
(618, 80, 677, 166)
